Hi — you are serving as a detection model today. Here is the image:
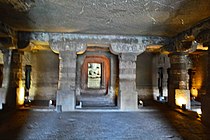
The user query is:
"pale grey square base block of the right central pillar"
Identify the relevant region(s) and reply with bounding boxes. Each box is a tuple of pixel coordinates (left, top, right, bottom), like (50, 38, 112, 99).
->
(119, 91, 138, 111)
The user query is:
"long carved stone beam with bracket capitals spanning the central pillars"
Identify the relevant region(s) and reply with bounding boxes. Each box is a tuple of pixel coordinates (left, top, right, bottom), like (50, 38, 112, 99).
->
(18, 32, 169, 54)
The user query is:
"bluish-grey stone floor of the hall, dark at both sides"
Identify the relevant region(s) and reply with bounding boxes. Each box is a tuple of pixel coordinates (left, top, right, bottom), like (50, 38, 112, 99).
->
(0, 104, 210, 140)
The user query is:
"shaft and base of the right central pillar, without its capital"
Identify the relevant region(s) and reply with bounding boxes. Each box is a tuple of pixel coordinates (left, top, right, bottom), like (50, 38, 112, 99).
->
(119, 53, 138, 110)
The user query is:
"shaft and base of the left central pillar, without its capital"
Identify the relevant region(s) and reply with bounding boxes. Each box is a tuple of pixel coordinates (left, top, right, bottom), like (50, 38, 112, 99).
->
(56, 51, 77, 111)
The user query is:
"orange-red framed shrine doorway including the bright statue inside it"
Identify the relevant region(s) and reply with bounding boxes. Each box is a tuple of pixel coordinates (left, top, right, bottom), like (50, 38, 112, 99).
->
(81, 55, 110, 95)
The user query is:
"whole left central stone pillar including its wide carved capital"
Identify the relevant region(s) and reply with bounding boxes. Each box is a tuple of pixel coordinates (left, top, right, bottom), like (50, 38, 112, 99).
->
(50, 39, 86, 112)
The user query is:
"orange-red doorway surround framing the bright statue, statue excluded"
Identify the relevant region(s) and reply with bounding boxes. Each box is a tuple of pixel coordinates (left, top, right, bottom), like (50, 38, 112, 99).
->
(81, 55, 110, 94)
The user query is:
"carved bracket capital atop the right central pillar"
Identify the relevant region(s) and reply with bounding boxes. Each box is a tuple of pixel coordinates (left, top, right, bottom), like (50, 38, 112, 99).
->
(110, 43, 146, 55)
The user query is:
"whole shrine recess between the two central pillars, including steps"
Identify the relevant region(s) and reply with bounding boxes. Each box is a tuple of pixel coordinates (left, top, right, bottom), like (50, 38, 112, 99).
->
(76, 46, 119, 107)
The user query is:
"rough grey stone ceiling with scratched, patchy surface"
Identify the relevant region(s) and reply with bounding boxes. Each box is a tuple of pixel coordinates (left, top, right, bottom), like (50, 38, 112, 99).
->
(0, 0, 210, 37)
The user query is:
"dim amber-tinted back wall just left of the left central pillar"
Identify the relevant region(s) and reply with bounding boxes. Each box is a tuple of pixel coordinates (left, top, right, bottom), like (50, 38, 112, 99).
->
(22, 51, 59, 100)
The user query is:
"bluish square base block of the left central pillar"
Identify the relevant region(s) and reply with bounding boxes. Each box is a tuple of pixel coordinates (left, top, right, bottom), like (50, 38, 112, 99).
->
(56, 90, 76, 112)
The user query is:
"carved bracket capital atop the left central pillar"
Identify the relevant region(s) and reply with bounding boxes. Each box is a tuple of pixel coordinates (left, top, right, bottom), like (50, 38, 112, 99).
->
(50, 40, 87, 53)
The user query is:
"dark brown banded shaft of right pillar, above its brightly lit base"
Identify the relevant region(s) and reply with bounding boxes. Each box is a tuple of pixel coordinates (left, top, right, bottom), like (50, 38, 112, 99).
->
(168, 52, 189, 106)
